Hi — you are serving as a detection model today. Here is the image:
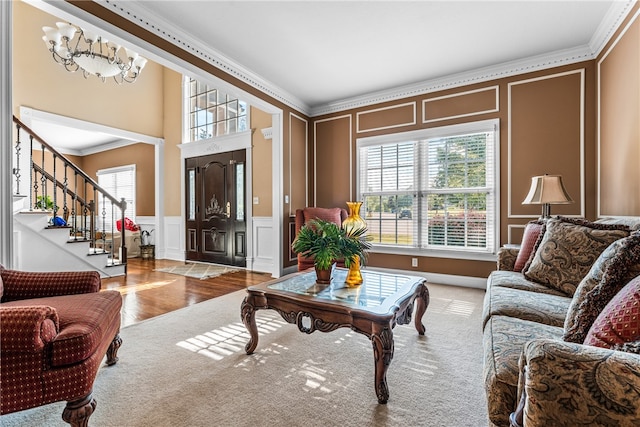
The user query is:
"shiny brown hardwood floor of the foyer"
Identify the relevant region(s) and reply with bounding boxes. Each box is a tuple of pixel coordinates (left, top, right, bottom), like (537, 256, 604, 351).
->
(102, 258, 271, 327)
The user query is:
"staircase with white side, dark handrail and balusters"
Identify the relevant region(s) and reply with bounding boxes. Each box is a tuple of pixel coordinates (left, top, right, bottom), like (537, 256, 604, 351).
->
(13, 116, 127, 277)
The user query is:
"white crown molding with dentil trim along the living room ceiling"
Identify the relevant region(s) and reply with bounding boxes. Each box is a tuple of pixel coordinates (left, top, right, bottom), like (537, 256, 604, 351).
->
(37, 0, 636, 117)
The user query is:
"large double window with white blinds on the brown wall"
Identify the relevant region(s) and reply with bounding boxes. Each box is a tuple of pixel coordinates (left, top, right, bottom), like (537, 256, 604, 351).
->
(357, 120, 499, 254)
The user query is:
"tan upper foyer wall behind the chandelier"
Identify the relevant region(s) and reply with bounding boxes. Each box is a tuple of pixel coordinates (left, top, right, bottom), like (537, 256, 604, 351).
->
(13, 1, 163, 137)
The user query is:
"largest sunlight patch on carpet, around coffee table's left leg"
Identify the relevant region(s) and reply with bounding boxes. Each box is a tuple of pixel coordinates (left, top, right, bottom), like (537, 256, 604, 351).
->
(176, 313, 286, 360)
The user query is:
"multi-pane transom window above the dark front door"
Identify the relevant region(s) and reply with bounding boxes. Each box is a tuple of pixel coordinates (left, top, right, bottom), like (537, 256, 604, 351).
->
(183, 76, 249, 142)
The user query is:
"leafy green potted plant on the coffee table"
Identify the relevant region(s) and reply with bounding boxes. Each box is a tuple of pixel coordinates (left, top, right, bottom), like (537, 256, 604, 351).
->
(292, 219, 371, 284)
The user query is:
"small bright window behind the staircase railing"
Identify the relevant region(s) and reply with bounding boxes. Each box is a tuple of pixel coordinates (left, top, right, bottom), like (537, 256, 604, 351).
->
(97, 165, 136, 231)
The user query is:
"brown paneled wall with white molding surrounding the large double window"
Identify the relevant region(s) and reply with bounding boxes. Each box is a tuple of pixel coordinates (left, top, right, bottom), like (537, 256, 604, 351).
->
(309, 61, 595, 277)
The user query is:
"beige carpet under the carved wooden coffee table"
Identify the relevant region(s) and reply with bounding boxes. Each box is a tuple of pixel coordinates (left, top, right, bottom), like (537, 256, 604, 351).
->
(0, 285, 487, 427)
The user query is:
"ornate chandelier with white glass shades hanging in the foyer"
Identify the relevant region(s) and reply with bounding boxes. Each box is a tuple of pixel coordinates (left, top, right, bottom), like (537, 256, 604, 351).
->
(42, 22, 147, 84)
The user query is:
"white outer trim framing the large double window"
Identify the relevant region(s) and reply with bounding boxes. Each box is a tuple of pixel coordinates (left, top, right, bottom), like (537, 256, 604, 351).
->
(356, 119, 500, 261)
